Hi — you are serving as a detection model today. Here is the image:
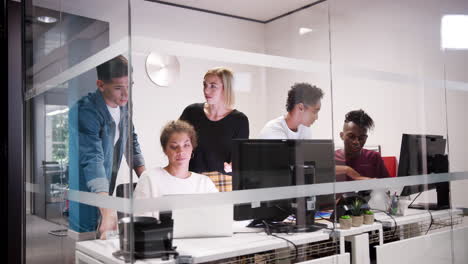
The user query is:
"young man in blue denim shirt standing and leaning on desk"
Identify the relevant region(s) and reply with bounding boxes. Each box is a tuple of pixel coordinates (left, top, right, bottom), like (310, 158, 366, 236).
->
(69, 56, 145, 239)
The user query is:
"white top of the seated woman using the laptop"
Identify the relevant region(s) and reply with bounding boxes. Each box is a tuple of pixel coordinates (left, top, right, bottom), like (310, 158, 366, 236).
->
(133, 167, 218, 218)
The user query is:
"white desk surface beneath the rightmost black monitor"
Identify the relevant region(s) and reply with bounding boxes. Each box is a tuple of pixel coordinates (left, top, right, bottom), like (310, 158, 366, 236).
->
(375, 208, 463, 227)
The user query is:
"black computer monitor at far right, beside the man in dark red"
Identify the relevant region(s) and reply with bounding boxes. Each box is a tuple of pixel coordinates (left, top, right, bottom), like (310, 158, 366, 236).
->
(398, 134, 450, 210)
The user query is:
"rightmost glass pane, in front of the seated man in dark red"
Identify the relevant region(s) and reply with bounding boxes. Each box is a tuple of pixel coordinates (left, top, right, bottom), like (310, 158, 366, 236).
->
(329, 1, 467, 263)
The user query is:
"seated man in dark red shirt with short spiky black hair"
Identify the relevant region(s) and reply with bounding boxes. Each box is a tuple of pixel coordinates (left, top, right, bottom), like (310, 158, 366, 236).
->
(335, 109, 390, 181)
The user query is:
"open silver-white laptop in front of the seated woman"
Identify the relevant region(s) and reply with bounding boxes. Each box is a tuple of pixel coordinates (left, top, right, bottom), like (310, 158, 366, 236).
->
(172, 204, 234, 238)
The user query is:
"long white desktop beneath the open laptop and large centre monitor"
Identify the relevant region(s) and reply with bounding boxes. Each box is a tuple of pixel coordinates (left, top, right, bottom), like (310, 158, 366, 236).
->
(76, 226, 330, 264)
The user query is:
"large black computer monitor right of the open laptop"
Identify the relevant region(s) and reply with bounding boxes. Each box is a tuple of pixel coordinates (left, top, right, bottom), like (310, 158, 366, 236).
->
(232, 139, 335, 226)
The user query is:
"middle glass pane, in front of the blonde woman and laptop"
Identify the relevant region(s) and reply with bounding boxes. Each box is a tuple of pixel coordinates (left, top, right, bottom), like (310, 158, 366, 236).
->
(132, 1, 338, 262)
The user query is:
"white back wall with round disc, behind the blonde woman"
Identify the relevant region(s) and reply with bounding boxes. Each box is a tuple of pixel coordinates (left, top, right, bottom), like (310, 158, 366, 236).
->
(132, 1, 266, 167)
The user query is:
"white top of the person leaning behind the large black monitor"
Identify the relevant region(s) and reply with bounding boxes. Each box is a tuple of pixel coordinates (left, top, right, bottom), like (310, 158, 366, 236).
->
(258, 116, 312, 139)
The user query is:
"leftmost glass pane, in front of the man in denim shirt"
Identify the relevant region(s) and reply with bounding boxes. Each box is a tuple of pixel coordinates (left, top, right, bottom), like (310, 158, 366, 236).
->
(23, 0, 135, 263)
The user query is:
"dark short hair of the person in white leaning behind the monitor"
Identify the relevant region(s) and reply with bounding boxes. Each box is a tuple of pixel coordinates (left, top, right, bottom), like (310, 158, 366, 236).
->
(286, 83, 323, 112)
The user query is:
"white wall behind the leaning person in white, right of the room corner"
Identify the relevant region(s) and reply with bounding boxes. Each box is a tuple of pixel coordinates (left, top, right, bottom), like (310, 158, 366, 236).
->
(265, 3, 333, 139)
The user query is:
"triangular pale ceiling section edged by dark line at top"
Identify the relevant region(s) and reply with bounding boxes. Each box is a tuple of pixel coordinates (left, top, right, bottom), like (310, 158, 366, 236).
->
(148, 0, 323, 22)
